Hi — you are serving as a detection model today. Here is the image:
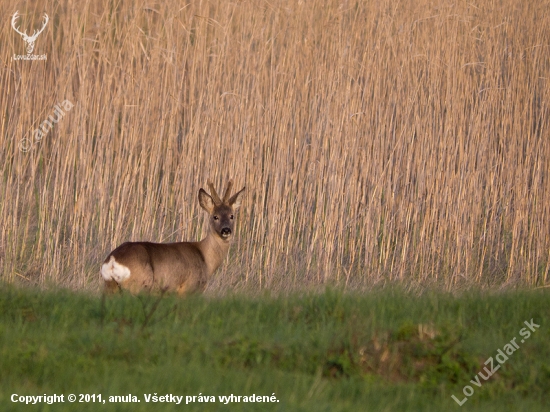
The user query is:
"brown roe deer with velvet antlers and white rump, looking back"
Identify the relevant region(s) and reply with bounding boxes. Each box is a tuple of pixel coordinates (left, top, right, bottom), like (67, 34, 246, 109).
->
(101, 180, 245, 294)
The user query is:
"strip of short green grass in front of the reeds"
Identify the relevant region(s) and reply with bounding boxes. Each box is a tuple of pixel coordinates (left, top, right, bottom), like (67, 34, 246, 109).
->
(0, 287, 550, 411)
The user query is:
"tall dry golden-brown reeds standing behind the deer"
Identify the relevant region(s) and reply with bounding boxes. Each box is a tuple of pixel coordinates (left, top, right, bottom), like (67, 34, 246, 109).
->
(0, 0, 550, 293)
